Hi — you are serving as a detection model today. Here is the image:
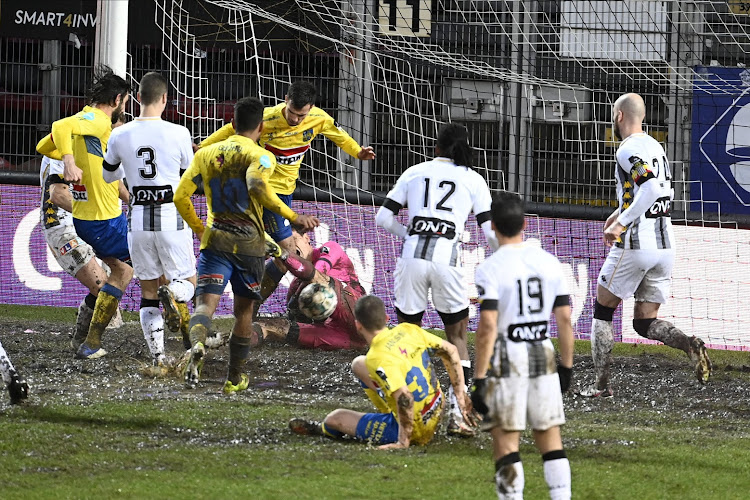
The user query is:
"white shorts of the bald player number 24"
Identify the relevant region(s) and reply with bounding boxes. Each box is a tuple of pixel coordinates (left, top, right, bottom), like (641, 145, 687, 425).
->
(597, 247, 675, 304)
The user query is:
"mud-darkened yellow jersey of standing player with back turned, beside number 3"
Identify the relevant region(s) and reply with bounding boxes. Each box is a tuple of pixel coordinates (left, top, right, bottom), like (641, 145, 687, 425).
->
(174, 135, 297, 257)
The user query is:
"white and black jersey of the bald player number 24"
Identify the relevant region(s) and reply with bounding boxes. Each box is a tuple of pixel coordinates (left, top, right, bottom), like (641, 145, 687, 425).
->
(615, 133, 674, 250)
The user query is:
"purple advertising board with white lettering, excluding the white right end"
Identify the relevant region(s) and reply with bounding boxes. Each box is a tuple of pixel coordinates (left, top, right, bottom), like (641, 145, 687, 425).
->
(0, 185, 619, 338)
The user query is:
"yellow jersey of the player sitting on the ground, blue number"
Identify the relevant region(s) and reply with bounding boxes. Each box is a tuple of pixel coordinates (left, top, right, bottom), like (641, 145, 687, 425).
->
(365, 323, 443, 444)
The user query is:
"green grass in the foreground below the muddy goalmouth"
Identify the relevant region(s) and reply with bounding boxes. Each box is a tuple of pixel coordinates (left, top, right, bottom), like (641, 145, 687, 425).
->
(0, 306, 750, 500)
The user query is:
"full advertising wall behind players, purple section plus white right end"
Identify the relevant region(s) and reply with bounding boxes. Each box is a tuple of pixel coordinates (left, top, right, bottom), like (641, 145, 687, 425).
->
(0, 184, 750, 350)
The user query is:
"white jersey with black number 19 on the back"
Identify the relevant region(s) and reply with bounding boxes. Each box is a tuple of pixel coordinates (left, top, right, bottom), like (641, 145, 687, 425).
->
(476, 239, 570, 377)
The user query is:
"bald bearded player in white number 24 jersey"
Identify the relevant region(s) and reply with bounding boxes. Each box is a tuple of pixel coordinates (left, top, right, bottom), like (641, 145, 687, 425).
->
(581, 94, 712, 397)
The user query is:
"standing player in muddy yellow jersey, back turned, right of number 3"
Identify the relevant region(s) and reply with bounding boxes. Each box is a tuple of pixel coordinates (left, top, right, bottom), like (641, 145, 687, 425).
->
(174, 98, 318, 393)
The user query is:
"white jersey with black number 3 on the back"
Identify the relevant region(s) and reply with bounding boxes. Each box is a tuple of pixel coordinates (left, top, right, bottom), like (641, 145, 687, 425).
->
(104, 117, 193, 231)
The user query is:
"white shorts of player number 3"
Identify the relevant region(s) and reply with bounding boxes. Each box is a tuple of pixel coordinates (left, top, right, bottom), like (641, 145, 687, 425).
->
(128, 228, 195, 281)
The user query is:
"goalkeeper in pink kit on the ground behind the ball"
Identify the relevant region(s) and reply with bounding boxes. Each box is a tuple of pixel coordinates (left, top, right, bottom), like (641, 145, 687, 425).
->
(256, 225, 367, 349)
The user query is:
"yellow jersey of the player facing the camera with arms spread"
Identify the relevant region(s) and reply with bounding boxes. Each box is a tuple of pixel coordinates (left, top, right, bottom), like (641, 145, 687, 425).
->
(201, 102, 362, 194)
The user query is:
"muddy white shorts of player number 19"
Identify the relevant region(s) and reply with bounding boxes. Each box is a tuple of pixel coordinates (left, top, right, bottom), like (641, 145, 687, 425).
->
(482, 373, 565, 432)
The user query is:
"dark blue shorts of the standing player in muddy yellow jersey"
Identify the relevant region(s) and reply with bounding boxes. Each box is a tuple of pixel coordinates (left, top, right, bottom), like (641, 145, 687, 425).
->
(195, 248, 264, 300)
